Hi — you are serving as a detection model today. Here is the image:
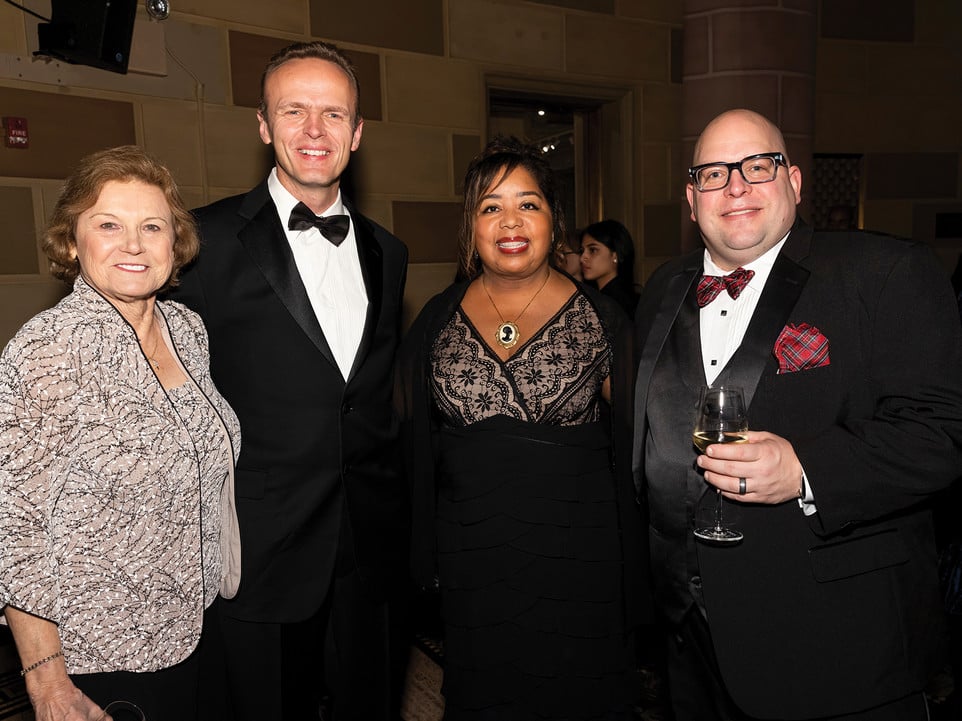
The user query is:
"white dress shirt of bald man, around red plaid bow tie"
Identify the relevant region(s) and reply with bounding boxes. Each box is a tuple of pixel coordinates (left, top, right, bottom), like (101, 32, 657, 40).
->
(699, 233, 788, 385)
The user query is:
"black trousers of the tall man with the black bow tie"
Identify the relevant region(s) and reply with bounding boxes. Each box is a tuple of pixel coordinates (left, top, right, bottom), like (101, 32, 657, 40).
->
(201, 572, 399, 721)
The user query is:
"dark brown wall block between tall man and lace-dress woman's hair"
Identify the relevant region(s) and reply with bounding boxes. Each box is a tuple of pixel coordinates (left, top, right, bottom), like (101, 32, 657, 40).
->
(393, 200, 462, 263)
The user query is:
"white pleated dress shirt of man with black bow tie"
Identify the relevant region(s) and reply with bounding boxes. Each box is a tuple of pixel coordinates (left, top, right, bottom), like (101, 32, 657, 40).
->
(267, 168, 368, 379)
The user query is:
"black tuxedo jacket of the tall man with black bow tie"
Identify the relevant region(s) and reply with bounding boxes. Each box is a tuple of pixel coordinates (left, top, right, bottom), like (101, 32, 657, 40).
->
(172, 181, 409, 622)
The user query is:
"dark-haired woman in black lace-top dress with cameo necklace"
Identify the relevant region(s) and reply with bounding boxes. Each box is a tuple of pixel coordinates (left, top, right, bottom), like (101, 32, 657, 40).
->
(397, 139, 647, 721)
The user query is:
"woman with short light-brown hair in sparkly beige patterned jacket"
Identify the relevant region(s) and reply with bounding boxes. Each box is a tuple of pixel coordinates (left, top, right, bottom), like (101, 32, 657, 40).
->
(0, 146, 240, 721)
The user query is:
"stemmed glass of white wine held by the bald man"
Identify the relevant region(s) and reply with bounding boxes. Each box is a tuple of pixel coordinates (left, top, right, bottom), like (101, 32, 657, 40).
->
(692, 386, 748, 543)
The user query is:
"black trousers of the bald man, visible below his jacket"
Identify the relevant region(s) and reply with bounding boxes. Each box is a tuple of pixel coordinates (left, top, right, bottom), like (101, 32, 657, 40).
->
(668, 608, 928, 721)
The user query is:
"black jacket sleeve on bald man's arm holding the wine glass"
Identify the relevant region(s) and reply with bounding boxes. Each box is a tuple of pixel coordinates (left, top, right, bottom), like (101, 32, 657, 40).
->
(796, 244, 962, 534)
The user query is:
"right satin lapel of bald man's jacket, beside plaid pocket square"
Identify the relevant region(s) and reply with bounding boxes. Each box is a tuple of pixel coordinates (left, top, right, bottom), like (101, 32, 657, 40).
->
(726, 226, 811, 410)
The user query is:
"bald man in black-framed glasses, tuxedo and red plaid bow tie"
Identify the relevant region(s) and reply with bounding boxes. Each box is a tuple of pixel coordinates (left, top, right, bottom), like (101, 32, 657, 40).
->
(634, 110, 962, 721)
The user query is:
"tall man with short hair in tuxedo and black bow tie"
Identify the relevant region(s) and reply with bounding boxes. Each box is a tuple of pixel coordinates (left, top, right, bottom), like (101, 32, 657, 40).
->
(173, 42, 409, 721)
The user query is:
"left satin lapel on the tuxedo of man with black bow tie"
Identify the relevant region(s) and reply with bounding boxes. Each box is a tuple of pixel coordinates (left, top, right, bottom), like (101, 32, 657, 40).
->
(237, 181, 337, 368)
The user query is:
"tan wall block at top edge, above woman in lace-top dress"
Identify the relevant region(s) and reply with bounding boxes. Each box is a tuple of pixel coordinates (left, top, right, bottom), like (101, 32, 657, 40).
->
(448, 0, 564, 70)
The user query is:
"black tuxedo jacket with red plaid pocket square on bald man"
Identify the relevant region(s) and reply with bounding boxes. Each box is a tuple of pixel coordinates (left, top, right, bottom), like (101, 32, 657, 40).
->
(634, 223, 962, 719)
